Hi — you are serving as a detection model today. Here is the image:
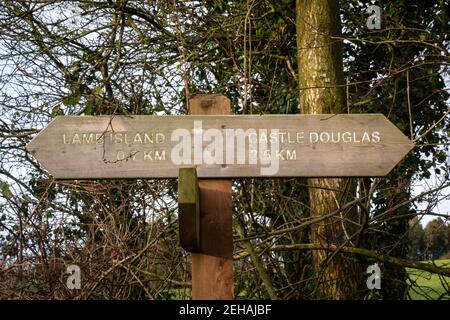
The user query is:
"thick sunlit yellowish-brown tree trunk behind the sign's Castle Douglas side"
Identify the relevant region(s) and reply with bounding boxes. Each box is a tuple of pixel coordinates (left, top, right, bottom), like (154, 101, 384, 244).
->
(296, 0, 365, 299)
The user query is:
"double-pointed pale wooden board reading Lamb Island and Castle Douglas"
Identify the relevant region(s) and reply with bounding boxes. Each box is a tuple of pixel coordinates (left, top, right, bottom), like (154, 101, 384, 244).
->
(27, 113, 414, 179)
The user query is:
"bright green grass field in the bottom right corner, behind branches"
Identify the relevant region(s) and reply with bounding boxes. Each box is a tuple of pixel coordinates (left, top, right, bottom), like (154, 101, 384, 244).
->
(407, 259, 450, 300)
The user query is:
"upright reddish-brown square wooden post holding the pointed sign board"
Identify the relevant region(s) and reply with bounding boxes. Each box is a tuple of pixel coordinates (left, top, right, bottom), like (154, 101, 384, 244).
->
(189, 94, 234, 300)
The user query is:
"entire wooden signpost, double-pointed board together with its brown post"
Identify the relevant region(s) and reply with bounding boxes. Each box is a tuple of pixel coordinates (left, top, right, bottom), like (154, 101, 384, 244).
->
(27, 95, 414, 299)
